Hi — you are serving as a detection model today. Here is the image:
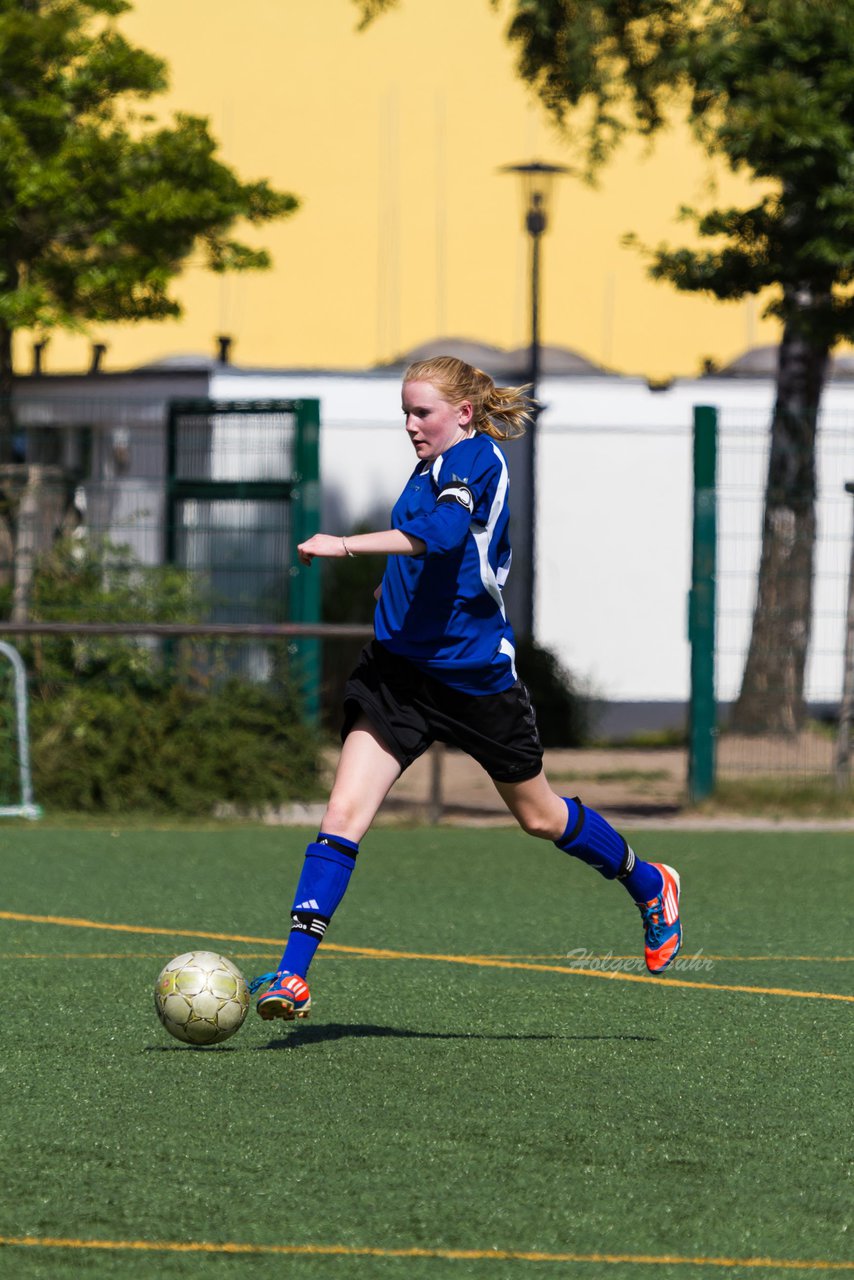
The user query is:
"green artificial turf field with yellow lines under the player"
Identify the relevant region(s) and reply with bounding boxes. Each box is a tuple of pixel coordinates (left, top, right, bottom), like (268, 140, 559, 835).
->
(0, 824, 854, 1280)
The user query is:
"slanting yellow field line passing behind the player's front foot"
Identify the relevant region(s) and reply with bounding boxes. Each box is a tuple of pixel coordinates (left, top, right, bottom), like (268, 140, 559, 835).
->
(0, 911, 854, 1004)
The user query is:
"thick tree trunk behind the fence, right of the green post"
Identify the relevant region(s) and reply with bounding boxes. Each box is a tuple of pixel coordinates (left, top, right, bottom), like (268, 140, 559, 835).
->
(730, 304, 828, 735)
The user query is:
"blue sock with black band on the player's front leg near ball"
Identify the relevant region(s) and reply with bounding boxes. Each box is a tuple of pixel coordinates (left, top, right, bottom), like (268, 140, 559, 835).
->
(279, 831, 359, 978)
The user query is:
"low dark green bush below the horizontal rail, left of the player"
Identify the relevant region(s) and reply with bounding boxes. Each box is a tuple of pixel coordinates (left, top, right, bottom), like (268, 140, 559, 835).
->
(31, 678, 319, 814)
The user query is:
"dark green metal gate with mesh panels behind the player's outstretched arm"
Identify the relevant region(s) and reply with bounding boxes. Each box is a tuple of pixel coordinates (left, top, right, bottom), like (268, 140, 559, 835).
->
(165, 399, 320, 721)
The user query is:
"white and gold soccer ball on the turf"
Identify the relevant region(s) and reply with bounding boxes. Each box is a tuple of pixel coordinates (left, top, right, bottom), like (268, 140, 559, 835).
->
(154, 951, 250, 1044)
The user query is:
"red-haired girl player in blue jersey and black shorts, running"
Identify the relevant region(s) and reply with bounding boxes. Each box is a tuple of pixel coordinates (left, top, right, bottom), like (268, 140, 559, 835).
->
(257, 356, 681, 1020)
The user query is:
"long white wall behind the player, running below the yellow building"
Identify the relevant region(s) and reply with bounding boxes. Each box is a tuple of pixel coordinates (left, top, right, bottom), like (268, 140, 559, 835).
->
(211, 370, 854, 700)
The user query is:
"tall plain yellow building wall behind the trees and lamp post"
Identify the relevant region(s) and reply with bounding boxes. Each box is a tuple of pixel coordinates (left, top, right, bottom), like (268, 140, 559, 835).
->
(33, 0, 777, 378)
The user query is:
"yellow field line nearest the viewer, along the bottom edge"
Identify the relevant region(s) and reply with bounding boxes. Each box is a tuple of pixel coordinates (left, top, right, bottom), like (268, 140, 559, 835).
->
(0, 1235, 854, 1271)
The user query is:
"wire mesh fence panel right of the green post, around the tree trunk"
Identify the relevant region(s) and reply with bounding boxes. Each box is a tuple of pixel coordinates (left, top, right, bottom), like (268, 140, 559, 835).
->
(699, 404, 854, 787)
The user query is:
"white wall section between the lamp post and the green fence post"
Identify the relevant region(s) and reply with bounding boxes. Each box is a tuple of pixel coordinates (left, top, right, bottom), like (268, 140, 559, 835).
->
(536, 379, 691, 700)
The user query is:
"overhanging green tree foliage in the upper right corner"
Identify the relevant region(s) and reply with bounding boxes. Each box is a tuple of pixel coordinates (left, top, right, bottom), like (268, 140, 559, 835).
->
(496, 0, 854, 347)
